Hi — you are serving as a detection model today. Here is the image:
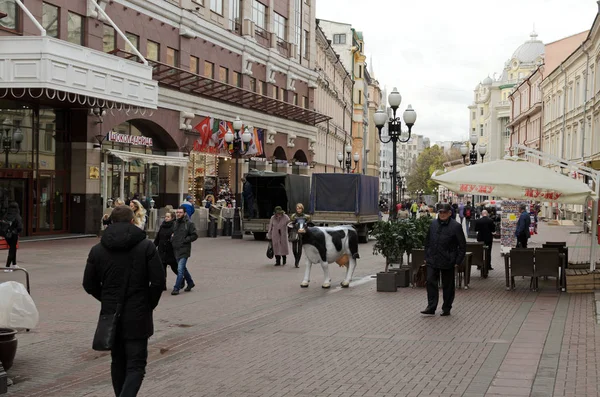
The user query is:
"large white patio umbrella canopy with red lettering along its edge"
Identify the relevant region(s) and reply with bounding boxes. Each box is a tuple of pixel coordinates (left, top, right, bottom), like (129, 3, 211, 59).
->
(431, 157, 596, 204)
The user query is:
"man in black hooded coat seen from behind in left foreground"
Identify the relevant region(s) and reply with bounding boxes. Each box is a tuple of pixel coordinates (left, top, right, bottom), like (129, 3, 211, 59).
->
(83, 205, 165, 397)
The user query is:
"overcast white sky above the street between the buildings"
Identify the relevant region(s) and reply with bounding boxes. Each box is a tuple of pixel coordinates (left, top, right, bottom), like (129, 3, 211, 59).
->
(317, 0, 598, 142)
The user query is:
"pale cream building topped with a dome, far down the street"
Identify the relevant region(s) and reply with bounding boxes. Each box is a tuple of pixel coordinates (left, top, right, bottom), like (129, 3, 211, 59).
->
(469, 32, 544, 161)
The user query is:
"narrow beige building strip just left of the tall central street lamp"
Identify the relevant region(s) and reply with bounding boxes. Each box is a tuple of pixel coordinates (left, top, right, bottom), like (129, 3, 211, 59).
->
(365, 60, 382, 176)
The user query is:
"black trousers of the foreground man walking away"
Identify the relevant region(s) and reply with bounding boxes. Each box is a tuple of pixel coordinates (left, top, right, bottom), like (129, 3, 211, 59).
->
(110, 336, 148, 397)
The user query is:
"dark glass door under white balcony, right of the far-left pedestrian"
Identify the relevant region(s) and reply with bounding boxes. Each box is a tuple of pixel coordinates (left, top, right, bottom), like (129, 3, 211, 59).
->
(34, 172, 67, 233)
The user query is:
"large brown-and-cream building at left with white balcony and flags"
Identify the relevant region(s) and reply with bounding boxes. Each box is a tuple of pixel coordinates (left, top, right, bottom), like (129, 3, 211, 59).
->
(0, 0, 329, 235)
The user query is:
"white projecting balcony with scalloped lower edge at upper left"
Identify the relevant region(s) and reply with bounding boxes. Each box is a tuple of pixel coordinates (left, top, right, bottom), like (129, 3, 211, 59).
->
(0, 36, 158, 109)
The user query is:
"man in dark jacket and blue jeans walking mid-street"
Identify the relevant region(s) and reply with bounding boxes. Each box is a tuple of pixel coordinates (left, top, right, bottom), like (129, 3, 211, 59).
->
(171, 205, 198, 295)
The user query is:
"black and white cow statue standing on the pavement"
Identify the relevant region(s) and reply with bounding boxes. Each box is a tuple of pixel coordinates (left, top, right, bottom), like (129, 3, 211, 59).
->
(289, 218, 359, 288)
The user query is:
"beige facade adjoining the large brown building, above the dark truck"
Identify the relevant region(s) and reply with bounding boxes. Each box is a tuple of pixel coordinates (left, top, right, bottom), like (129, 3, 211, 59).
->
(314, 20, 352, 172)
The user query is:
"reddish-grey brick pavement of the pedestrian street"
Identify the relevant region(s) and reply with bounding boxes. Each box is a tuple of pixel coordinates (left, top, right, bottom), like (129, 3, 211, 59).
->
(0, 224, 600, 397)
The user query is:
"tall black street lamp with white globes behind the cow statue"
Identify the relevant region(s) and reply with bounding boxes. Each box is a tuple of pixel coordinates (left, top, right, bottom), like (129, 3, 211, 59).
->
(373, 87, 417, 220)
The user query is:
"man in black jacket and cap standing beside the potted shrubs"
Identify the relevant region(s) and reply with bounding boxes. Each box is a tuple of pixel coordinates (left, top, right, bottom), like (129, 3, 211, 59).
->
(421, 203, 467, 316)
